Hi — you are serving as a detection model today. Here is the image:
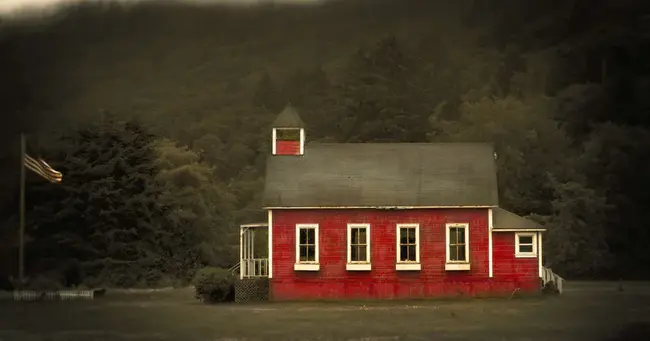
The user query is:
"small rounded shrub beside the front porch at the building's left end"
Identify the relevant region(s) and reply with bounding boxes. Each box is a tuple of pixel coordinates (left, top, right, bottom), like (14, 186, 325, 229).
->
(192, 267, 235, 303)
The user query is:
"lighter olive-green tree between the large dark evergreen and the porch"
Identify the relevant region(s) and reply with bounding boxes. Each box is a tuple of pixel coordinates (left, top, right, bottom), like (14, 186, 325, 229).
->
(156, 140, 238, 270)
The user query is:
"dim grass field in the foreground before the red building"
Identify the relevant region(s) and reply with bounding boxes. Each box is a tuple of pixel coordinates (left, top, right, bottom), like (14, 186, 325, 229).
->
(0, 282, 650, 341)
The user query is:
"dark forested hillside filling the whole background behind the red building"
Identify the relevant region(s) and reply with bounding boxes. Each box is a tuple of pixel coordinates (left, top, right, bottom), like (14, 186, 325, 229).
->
(0, 0, 650, 286)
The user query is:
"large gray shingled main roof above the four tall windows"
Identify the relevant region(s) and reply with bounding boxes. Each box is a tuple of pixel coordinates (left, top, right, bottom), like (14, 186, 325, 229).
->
(263, 143, 498, 207)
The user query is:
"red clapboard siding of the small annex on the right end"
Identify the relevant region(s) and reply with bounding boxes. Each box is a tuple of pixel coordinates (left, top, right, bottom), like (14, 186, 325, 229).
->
(492, 232, 539, 290)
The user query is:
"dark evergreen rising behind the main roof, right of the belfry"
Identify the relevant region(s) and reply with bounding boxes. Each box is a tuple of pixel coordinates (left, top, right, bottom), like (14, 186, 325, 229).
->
(331, 37, 428, 142)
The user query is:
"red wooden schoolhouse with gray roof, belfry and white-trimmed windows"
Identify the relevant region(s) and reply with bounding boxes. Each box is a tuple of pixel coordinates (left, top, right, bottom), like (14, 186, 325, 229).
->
(235, 106, 556, 300)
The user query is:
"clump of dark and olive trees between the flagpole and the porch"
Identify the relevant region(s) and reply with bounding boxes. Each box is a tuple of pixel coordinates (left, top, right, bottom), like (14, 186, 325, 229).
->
(14, 118, 237, 286)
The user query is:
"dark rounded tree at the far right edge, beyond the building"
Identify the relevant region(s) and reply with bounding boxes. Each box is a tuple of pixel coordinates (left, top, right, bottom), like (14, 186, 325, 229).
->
(580, 123, 650, 278)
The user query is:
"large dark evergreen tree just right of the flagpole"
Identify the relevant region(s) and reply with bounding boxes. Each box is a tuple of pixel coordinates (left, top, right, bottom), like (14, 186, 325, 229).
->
(28, 119, 168, 286)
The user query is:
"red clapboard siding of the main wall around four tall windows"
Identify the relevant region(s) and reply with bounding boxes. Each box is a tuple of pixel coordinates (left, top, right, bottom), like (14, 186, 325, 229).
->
(271, 209, 528, 300)
